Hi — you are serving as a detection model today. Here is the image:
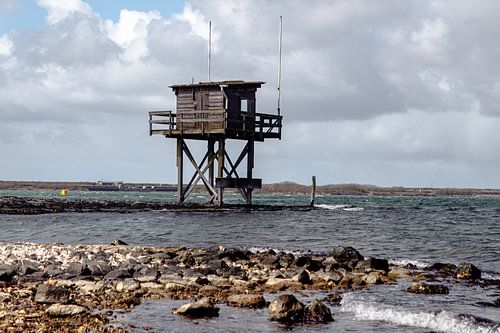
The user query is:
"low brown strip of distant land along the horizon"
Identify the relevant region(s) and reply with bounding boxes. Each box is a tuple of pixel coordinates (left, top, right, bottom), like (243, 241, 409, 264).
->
(0, 181, 500, 196)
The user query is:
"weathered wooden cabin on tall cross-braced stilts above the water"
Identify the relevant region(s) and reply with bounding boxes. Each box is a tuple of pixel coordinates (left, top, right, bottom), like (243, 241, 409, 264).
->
(149, 81, 282, 205)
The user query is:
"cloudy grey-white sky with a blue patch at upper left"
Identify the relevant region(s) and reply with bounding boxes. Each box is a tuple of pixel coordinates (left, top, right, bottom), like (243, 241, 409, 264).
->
(0, 0, 500, 188)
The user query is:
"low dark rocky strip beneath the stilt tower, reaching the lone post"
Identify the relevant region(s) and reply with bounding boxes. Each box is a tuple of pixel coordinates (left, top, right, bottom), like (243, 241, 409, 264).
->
(0, 196, 311, 215)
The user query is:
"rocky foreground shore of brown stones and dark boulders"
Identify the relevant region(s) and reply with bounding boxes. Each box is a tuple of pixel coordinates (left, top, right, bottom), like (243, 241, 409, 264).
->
(0, 241, 492, 332)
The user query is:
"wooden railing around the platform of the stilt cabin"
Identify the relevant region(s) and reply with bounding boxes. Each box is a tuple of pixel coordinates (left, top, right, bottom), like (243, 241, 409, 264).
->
(149, 110, 283, 139)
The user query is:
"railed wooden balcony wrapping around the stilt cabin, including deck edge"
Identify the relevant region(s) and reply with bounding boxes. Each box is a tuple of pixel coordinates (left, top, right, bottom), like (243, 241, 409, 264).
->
(149, 109, 283, 141)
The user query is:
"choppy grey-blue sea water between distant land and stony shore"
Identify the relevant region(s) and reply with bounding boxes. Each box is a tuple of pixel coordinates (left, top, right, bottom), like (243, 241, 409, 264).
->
(0, 191, 500, 332)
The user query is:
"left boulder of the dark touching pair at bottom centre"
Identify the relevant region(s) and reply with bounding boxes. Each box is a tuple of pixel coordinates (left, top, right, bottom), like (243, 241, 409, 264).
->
(268, 295, 304, 323)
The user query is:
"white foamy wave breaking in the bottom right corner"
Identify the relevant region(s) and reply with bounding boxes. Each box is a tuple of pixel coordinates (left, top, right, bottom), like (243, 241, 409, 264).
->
(340, 293, 500, 333)
